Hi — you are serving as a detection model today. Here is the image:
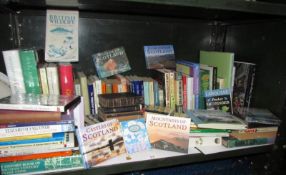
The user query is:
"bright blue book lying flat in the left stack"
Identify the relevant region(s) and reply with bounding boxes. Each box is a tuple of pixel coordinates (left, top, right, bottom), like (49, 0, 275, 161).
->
(0, 132, 65, 146)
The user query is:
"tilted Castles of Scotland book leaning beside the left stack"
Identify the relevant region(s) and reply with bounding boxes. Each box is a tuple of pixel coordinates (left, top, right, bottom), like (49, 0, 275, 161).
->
(76, 119, 126, 168)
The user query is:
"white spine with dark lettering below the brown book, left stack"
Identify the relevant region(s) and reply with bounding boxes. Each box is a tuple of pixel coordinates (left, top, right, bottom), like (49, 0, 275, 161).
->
(0, 124, 74, 138)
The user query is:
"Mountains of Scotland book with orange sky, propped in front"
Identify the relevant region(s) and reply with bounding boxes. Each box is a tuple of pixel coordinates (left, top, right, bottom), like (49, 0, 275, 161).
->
(146, 112, 191, 153)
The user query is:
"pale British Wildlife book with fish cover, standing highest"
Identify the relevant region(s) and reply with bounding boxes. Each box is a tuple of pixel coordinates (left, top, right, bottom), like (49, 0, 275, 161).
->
(45, 10, 79, 62)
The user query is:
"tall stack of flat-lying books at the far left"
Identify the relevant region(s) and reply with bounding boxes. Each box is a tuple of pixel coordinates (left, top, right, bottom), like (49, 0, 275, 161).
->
(0, 94, 83, 174)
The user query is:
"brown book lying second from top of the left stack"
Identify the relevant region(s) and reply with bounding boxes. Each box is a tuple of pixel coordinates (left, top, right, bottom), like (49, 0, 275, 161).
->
(0, 109, 61, 124)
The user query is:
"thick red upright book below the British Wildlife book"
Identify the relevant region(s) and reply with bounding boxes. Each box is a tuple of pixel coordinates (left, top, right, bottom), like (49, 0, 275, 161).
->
(59, 63, 74, 95)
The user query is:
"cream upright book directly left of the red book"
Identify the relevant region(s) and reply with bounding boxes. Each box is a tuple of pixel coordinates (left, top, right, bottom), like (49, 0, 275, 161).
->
(46, 63, 60, 95)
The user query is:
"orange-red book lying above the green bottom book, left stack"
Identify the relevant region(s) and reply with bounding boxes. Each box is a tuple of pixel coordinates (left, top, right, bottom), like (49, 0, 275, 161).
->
(0, 150, 72, 163)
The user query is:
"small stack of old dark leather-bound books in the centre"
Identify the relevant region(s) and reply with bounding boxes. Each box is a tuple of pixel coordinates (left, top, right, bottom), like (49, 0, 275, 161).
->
(98, 92, 144, 121)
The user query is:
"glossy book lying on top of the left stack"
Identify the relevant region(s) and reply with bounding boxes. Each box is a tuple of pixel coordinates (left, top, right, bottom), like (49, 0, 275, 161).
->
(0, 94, 81, 112)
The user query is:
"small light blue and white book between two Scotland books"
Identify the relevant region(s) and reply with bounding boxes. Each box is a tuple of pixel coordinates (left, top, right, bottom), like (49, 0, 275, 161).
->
(120, 118, 151, 154)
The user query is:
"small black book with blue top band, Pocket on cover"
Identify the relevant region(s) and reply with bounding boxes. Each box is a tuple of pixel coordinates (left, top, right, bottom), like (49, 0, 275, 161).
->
(204, 89, 232, 113)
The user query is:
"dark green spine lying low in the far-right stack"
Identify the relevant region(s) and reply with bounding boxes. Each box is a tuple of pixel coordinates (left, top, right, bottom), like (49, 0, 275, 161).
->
(222, 137, 272, 148)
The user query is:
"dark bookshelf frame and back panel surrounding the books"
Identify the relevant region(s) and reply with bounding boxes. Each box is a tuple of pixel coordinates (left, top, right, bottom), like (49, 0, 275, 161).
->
(0, 0, 286, 174)
